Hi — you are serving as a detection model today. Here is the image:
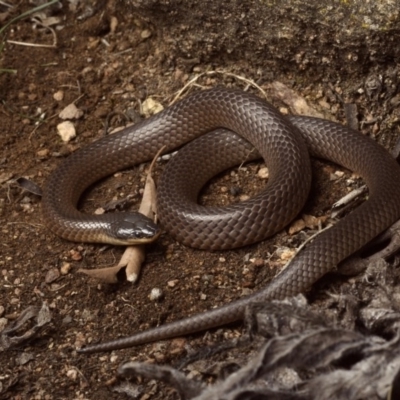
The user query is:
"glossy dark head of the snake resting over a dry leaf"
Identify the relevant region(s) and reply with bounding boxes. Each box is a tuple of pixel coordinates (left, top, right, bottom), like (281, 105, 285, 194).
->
(110, 213, 161, 245)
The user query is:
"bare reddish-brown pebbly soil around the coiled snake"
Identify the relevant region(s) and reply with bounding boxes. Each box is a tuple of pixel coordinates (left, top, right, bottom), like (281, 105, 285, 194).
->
(0, 5, 398, 400)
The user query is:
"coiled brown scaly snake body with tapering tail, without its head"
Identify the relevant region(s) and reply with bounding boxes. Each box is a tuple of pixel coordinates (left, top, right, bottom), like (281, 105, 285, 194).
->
(43, 89, 400, 353)
